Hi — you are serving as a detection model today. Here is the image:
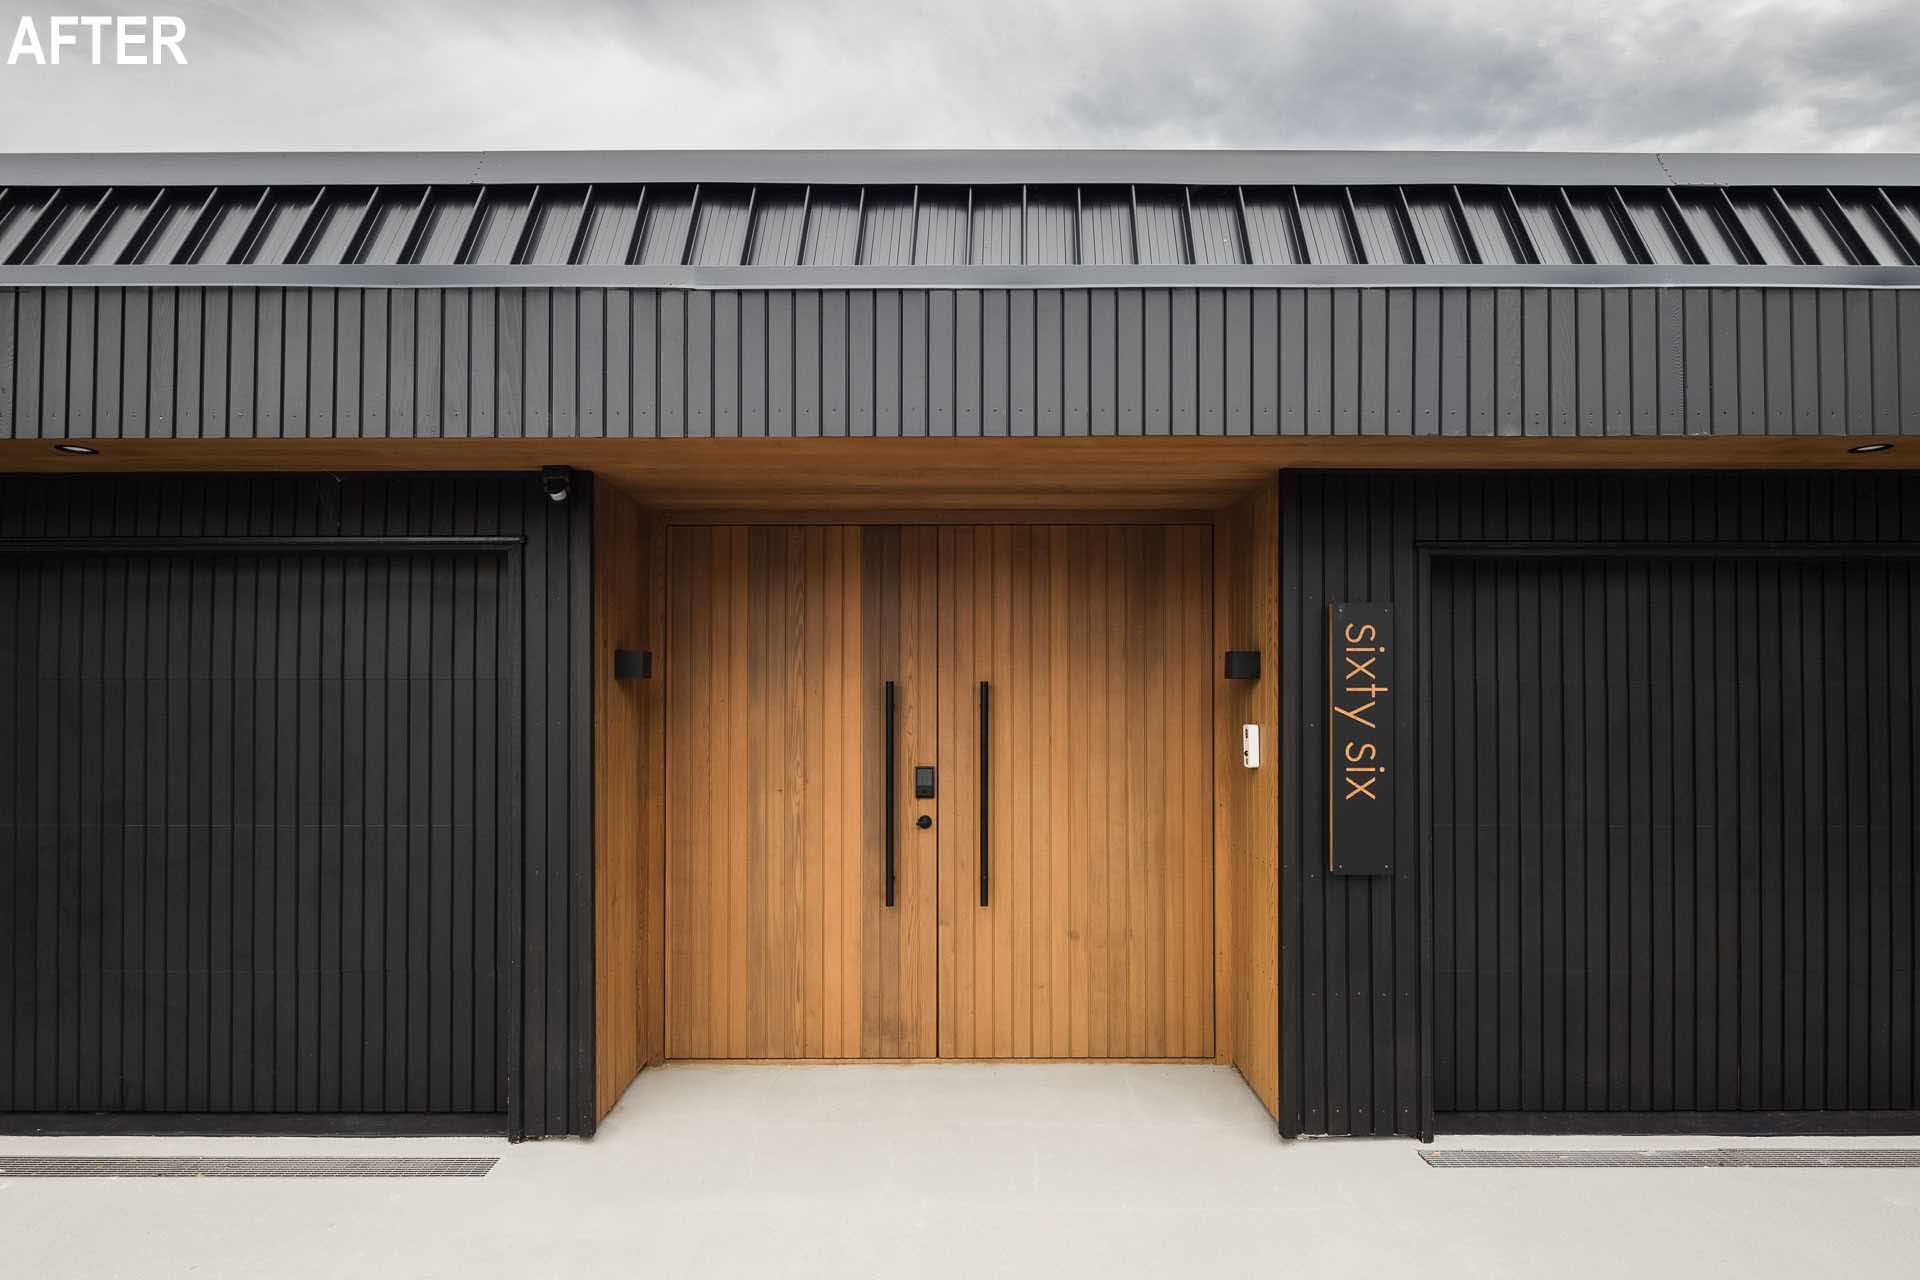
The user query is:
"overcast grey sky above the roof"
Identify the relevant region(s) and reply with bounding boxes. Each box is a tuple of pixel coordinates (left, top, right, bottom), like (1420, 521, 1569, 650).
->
(0, 0, 1920, 150)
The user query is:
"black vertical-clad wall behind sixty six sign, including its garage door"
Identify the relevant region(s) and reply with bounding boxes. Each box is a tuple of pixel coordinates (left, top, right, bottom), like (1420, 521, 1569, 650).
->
(1281, 474, 1920, 1134)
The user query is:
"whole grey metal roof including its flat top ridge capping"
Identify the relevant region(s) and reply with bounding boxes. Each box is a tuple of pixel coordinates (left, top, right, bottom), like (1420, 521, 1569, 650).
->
(0, 152, 1920, 288)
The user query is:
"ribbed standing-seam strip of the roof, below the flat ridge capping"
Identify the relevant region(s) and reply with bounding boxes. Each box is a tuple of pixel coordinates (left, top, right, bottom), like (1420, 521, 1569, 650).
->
(0, 172, 1920, 284)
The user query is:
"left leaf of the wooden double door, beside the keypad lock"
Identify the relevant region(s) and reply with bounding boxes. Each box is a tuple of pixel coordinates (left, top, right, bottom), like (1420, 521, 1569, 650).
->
(662, 526, 935, 1057)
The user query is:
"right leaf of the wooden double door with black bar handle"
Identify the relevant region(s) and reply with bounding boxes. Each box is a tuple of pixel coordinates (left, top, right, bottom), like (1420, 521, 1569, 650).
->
(939, 526, 1213, 1057)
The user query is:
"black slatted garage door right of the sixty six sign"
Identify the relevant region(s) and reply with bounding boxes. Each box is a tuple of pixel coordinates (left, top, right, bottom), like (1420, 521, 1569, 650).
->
(1430, 555, 1920, 1128)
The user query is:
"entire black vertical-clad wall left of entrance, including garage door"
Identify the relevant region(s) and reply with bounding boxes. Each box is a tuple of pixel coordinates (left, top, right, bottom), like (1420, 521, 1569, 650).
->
(0, 476, 593, 1136)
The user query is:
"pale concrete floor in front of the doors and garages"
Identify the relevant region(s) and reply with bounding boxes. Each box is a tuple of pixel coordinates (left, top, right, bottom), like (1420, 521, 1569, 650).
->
(0, 1065, 1920, 1280)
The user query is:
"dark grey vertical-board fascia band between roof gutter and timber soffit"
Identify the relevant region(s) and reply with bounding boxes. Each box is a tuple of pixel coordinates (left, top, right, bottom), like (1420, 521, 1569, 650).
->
(0, 288, 1920, 439)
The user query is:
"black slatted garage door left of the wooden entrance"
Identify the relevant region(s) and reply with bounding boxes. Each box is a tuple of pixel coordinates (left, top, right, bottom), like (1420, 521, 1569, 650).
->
(0, 553, 518, 1115)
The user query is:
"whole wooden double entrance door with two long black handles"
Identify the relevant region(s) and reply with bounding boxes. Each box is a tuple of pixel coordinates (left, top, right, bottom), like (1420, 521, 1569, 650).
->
(664, 524, 1213, 1059)
